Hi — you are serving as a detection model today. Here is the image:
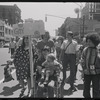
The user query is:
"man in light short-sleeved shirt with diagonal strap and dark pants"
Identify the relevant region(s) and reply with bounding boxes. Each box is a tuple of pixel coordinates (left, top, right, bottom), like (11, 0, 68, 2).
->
(60, 31, 77, 94)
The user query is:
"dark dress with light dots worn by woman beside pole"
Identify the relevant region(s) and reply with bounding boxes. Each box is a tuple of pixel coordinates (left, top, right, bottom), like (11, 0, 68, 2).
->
(14, 47, 30, 80)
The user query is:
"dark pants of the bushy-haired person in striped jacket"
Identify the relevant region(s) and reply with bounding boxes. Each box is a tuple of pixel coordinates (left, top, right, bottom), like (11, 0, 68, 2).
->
(83, 74, 100, 98)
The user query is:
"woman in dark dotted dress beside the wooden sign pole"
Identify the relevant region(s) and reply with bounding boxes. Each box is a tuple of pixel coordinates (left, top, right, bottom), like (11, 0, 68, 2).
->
(14, 36, 31, 97)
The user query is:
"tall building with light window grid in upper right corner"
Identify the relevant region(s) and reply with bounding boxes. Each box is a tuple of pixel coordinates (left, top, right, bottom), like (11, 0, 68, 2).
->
(82, 2, 100, 21)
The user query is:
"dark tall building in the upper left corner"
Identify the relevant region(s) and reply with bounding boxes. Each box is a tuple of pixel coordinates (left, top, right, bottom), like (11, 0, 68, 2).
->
(0, 4, 22, 25)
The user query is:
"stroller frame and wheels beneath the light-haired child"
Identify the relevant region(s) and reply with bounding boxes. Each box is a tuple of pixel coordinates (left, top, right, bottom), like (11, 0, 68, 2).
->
(37, 69, 61, 98)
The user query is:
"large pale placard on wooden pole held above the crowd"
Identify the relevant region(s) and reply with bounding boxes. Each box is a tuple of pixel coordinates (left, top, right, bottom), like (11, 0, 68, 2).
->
(13, 20, 45, 37)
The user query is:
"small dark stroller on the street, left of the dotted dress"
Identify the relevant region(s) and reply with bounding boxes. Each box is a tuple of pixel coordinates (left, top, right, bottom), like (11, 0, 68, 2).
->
(1, 60, 14, 83)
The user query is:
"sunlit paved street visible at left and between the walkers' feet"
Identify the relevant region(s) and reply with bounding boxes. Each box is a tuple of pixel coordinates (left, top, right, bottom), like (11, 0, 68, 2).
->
(0, 48, 89, 98)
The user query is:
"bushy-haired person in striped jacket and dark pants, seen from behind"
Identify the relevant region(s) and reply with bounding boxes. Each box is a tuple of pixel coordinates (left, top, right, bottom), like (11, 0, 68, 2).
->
(81, 33, 100, 98)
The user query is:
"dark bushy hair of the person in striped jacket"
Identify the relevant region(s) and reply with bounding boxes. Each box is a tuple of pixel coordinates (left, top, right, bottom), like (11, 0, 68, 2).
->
(86, 33, 100, 46)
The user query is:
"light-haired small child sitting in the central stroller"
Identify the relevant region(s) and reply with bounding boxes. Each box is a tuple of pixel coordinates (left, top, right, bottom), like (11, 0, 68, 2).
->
(42, 53, 62, 82)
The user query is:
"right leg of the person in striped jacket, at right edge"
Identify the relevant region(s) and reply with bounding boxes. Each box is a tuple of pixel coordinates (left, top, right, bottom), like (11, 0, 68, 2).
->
(92, 75, 100, 98)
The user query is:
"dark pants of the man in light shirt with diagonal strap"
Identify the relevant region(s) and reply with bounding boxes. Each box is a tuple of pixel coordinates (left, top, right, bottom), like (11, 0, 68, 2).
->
(62, 54, 76, 87)
